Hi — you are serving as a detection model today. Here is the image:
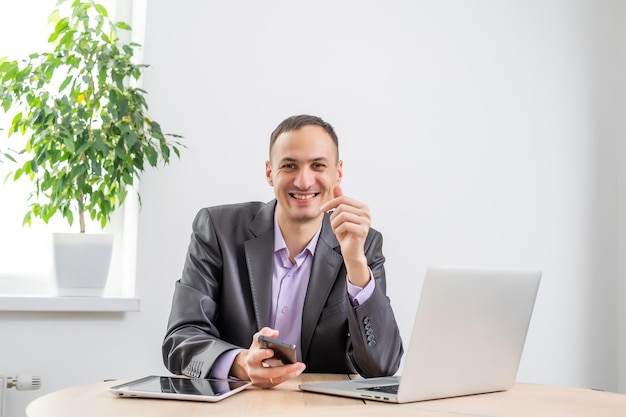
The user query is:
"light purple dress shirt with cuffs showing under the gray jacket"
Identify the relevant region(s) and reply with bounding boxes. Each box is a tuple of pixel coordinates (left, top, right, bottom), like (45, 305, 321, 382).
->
(210, 214, 375, 379)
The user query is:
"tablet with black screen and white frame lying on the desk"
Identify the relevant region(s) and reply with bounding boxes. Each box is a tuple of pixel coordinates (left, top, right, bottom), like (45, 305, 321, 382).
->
(109, 375, 251, 402)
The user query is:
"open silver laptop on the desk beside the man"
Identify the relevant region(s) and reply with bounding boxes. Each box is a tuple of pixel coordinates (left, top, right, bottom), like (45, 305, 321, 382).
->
(300, 266, 541, 403)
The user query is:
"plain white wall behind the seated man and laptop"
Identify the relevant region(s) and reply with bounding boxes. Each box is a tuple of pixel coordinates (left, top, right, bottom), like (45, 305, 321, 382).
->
(0, 0, 626, 415)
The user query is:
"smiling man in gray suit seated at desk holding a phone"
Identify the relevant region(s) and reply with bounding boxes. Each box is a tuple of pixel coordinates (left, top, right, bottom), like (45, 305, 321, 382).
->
(162, 115, 403, 388)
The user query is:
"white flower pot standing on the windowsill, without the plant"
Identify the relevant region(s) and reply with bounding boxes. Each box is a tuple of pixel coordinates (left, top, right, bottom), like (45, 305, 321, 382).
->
(52, 233, 113, 297)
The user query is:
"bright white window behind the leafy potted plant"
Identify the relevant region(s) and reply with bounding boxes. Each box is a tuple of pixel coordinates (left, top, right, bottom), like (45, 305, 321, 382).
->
(0, 0, 139, 297)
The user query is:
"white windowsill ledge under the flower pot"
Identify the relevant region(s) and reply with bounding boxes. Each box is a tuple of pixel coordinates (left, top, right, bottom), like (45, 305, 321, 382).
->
(0, 295, 139, 312)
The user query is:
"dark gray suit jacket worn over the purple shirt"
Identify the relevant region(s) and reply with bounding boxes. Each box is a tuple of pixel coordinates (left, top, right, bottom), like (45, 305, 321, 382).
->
(162, 200, 403, 377)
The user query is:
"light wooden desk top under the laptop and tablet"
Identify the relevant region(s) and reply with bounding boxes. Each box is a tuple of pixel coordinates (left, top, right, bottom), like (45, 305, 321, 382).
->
(26, 374, 626, 417)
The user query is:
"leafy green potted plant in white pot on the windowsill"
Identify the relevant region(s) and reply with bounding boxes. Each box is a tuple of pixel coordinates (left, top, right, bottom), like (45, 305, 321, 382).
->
(0, 0, 181, 295)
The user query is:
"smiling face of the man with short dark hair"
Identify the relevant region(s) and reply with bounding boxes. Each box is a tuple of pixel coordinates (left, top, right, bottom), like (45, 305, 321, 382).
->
(265, 125, 343, 224)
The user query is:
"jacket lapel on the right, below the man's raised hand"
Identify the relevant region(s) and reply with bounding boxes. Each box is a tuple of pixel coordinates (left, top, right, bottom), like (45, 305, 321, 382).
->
(301, 214, 343, 358)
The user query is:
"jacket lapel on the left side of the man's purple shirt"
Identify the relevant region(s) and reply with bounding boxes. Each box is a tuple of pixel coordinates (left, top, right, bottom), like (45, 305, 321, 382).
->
(244, 200, 276, 330)
